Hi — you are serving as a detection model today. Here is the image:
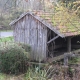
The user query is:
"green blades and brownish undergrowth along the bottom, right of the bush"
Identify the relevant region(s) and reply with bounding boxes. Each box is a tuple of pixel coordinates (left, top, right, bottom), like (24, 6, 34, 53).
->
(25, 62, 80, 80)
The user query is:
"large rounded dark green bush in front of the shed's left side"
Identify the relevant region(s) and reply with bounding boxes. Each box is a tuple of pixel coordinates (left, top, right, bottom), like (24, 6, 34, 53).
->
(0, 44, 29, 74)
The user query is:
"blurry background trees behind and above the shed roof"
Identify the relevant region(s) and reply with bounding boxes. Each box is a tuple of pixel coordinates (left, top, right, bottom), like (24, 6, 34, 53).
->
(0, 0, 80, 29)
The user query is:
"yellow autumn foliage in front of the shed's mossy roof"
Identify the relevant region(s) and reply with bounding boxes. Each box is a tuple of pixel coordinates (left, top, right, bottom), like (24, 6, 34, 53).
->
(54, 6, 78, 25)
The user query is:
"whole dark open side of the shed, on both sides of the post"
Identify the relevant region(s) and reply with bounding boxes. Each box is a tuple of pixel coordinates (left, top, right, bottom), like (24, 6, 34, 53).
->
(47, 28, 80, 57)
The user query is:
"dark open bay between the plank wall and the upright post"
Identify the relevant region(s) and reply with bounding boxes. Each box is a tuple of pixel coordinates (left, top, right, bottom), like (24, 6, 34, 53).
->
(47, 28, 67, 57)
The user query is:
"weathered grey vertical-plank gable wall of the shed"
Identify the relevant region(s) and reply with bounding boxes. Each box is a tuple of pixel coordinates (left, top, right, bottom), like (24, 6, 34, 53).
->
(14, 15, 47, 61)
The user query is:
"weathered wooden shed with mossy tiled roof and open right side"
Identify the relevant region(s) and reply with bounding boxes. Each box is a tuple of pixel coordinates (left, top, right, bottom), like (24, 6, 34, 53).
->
(10, 11, 80, 61)
